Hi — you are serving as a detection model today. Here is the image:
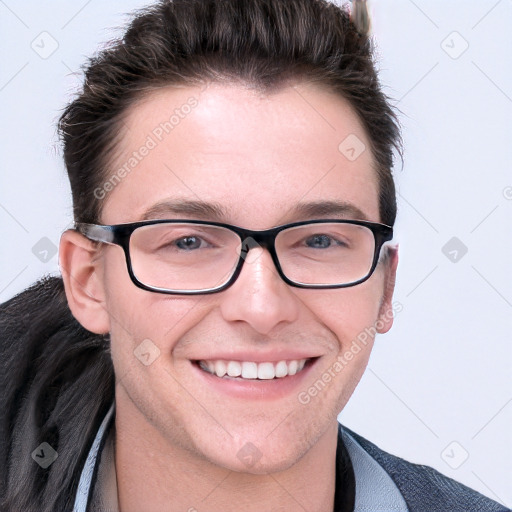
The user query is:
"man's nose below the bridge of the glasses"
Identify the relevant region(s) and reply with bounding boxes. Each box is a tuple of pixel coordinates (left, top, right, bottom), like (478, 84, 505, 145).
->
(220, 247, 299, 334)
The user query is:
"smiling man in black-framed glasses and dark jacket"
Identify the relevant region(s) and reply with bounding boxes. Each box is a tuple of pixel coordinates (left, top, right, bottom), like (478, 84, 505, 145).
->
(2, 0, 505, 512)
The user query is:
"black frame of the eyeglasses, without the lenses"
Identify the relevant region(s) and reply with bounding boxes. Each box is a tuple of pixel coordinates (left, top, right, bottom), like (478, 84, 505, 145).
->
(75, 219, 393, 295)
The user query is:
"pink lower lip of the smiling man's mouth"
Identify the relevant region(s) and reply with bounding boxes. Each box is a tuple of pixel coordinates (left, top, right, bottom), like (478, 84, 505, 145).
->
(191, 358, 319, 400)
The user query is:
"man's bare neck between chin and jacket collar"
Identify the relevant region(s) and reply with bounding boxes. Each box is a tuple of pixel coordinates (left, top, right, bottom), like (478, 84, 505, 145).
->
(115, 400, 338, 512)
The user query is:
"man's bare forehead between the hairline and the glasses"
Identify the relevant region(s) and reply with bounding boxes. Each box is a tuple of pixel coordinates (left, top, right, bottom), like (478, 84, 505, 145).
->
(102, 83, 379, 229)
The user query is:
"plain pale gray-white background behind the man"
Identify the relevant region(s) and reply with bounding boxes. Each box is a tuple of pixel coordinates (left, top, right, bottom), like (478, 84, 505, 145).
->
(0, 0, 512, 507)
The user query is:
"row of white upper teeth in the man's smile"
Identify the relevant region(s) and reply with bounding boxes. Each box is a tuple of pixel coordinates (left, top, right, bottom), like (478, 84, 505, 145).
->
(199, 359, 307, 379)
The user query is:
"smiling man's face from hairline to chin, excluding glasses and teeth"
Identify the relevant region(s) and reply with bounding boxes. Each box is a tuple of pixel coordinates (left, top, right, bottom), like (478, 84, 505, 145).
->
(64, 84, 397, 473)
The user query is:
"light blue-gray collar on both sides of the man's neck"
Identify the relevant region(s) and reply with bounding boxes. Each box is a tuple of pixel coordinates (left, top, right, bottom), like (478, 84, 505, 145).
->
(73, 404, 408, 512)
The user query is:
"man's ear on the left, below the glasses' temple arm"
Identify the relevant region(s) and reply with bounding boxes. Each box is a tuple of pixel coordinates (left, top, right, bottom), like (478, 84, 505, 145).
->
(59, 229, 110, 334)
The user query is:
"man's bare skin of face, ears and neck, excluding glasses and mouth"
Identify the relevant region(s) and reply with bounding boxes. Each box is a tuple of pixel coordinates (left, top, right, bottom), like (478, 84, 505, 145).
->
(60, 84, 398, 512)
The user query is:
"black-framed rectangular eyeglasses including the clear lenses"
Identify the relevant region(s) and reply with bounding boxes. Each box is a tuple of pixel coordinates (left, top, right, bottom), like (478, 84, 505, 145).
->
(76, 219, 393, 295)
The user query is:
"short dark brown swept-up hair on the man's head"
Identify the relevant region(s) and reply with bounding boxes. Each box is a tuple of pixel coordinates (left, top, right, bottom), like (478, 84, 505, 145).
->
(59, 0, 402, 225)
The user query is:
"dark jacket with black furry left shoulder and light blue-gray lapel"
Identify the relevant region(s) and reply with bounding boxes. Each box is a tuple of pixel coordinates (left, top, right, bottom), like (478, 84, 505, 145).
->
(0, 277, 510, 512)
